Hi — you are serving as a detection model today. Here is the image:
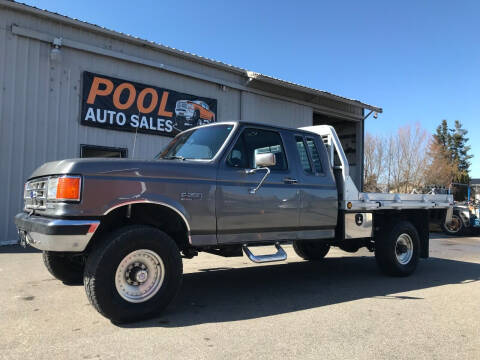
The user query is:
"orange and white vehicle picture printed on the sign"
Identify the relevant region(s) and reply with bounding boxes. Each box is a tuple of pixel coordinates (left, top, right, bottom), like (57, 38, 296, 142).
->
(173, 100, 215, 131)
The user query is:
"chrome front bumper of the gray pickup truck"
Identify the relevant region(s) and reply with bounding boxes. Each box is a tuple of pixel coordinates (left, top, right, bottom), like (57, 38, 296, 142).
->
(15, 213, 100, 252)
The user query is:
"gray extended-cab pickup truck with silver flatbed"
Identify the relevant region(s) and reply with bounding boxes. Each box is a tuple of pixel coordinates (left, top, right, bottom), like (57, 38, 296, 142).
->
(15, 122, 453, 322)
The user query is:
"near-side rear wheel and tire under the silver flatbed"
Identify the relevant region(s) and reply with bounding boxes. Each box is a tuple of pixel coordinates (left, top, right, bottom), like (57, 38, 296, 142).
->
(375, 221, 420, 276)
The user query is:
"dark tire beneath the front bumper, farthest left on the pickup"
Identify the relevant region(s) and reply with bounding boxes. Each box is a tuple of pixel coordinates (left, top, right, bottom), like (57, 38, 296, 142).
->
(42, 251, 85, 285)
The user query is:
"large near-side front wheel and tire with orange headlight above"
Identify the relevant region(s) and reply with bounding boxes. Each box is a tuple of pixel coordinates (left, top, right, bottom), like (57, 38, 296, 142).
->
(84, 225, 183, 323)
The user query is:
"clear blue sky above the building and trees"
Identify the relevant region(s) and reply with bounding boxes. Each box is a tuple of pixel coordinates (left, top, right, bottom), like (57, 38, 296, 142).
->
(20, 0, 480, 177)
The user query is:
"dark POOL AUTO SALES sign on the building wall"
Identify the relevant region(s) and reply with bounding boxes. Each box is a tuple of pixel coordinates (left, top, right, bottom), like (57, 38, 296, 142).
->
(81, 71, 217, 136)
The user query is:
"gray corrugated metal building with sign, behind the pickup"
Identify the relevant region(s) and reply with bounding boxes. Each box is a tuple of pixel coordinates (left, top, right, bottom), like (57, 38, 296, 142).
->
(0, 0, 382, 244)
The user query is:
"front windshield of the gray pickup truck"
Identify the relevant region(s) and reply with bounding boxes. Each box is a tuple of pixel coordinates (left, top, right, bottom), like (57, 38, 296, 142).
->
(156, 125, 233, 160)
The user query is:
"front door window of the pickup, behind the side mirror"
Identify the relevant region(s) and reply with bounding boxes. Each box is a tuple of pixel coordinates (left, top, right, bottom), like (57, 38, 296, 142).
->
(227, 128, 288, 170)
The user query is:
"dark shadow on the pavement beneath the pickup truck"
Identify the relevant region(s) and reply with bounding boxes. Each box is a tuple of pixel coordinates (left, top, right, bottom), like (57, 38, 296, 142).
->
(121, 257, 480, 328)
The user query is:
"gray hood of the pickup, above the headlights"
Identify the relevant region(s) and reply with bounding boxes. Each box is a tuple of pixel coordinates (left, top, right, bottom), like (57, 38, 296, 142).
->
(30, 158, 213, 178)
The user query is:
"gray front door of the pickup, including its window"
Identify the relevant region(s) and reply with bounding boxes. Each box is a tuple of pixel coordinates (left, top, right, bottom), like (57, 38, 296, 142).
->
(216, 126, 300, 244)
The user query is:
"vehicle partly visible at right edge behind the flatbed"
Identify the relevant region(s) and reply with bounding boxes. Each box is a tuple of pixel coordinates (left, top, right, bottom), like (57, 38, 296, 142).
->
(442, 200, 480, 236)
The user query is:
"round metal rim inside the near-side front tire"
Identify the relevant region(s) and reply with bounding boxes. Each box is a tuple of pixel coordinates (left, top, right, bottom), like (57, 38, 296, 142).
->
(115, 249, 165, 303)
